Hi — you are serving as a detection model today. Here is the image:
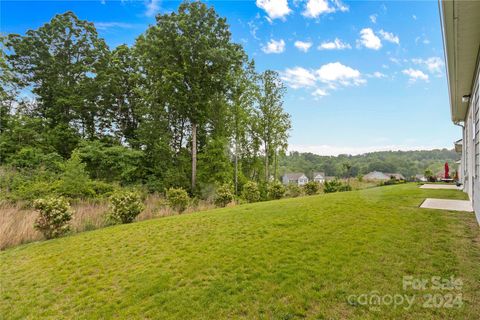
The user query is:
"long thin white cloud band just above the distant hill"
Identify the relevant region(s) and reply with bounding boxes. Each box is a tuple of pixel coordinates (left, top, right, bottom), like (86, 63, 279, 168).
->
(288, 144, 445, 156)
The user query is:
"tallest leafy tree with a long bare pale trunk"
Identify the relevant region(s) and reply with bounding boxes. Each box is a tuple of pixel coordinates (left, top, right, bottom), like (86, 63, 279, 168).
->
(141, 2, 243, 190)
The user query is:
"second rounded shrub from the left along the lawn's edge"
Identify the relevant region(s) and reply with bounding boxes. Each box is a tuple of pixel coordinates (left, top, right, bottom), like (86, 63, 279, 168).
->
(109, 191, 144, 223)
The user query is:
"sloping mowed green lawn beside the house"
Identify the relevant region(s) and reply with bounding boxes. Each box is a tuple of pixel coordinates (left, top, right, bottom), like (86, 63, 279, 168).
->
(0, 184, 480, 319)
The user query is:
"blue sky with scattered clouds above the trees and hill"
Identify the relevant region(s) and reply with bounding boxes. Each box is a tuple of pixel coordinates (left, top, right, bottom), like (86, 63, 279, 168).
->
(0, 0, 461, 155)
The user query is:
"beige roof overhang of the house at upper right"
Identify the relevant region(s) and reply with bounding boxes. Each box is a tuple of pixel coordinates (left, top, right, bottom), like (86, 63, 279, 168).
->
(441, 0, 480, 122)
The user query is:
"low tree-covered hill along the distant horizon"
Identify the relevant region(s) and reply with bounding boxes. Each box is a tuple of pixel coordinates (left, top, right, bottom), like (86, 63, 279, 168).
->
(278, 149, 460, 177)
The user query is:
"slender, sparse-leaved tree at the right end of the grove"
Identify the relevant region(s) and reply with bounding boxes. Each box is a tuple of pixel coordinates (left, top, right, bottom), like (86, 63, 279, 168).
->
(256, 70, 291, 181)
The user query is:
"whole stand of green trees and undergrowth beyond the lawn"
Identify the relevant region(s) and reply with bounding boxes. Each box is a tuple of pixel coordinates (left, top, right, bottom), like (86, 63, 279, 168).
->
(0, 2, 291, 201)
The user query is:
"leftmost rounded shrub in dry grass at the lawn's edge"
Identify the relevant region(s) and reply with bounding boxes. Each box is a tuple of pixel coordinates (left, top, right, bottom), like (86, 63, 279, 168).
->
(33, 197, 72, 239)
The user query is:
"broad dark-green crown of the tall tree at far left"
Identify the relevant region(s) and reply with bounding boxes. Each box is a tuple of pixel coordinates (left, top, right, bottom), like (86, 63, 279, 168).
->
(8, 12, 108, 137)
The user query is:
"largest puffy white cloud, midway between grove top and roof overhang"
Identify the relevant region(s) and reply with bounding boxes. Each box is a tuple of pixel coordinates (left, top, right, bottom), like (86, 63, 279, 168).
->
(315, 62, 366, 88)
